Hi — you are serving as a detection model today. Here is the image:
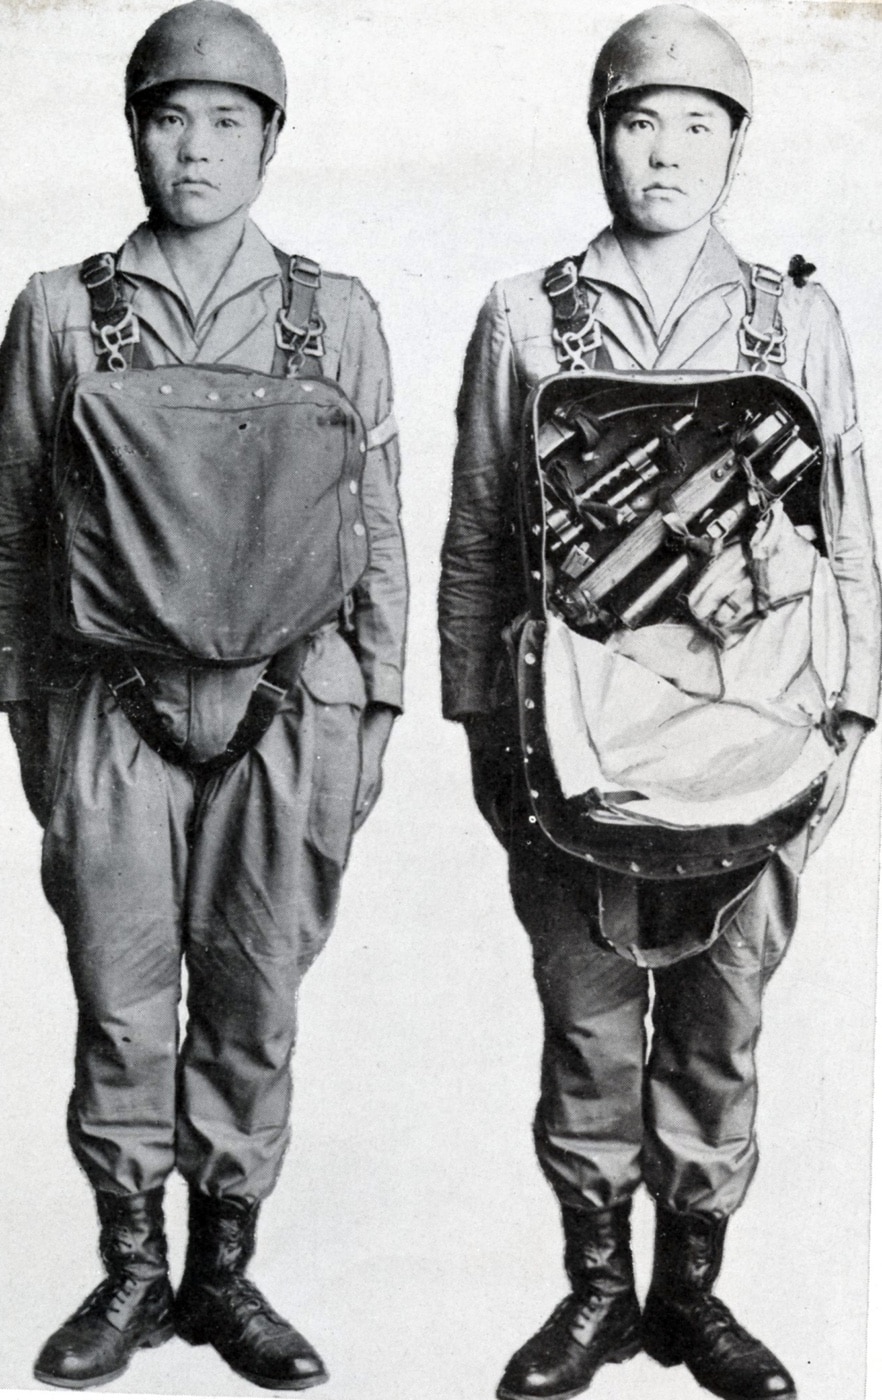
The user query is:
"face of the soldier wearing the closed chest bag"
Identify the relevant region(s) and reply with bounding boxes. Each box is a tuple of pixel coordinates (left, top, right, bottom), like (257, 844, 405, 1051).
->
(137, 83, 266, 228)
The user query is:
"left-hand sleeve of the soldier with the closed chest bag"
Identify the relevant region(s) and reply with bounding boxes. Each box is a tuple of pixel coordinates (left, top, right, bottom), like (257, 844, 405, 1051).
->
(0, 274, 60, 706)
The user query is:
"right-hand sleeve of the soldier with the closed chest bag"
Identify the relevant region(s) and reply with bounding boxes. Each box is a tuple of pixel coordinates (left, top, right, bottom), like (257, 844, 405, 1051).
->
(340, 281, 407, 710)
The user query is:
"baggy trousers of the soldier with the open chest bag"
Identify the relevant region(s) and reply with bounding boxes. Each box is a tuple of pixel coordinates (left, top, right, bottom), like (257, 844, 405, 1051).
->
(508, 802, 797, 1217)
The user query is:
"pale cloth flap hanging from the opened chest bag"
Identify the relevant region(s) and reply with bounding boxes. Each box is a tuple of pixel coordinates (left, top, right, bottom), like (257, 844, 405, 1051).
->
(543, 517, 846, 826)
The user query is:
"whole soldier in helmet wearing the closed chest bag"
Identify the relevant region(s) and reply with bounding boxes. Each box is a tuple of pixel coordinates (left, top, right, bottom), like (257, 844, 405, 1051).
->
(0, 0, 406, 1389)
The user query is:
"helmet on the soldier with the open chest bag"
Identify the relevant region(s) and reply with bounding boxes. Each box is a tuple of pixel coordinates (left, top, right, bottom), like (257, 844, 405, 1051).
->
(588, 4, 753, 134)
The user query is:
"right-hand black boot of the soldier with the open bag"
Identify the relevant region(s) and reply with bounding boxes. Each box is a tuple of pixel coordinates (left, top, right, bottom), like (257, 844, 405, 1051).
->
(643, 1207, 797, 1400)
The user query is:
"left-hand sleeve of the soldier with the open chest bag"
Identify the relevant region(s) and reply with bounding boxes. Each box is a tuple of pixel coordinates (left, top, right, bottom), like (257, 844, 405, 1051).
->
(438, 283, 524, 720)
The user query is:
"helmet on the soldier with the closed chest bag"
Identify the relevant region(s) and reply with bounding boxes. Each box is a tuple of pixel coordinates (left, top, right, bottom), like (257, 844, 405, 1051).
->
(126, 0, 287, 125)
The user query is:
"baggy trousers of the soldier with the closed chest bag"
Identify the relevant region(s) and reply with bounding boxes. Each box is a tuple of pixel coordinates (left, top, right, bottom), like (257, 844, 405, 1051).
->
(25, 633, 361, 1201)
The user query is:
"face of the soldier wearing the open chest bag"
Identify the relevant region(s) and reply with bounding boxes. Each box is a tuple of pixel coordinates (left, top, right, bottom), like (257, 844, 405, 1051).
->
(606, 88, 735, 237)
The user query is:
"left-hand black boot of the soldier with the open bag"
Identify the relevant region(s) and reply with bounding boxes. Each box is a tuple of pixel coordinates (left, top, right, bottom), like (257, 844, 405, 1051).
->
(497, 1201, 640, 1400)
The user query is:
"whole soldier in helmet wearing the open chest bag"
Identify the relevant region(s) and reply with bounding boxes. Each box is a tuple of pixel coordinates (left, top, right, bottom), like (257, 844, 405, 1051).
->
(440, 6, 881, 1400)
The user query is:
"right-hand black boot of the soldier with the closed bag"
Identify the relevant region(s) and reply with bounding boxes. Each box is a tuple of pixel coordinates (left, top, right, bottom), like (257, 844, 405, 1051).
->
(175, 1191, 328, 1390)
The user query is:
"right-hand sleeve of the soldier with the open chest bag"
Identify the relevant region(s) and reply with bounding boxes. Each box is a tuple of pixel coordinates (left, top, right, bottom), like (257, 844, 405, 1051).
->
(804, 286, 882, 721)
